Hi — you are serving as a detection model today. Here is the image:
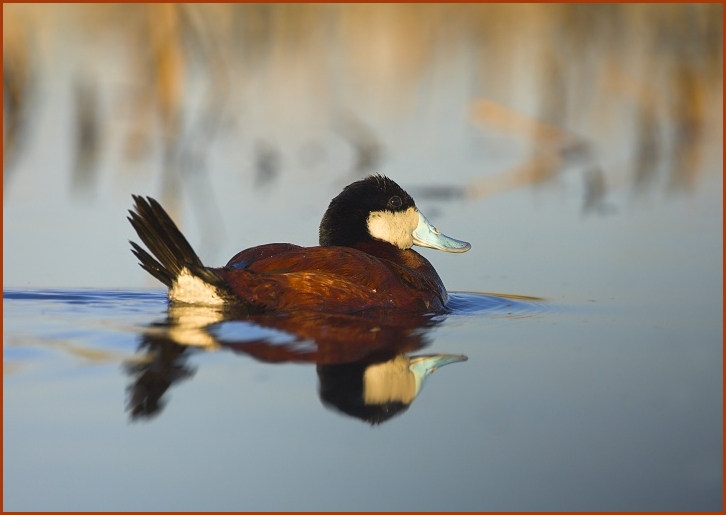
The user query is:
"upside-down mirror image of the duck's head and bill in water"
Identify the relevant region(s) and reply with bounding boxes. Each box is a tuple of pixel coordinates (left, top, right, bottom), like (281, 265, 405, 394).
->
(317, 354, 468, 424)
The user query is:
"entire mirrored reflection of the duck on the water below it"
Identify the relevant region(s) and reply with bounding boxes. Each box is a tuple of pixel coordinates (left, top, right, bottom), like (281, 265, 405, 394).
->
(125, 304, 467, 424)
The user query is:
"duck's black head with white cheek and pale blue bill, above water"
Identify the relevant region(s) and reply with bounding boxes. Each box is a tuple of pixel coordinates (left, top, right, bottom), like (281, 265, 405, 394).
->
(320, 175, 471, 252)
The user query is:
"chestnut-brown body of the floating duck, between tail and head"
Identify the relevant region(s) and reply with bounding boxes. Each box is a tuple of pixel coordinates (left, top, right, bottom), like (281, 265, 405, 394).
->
(219, 242, 448, 313)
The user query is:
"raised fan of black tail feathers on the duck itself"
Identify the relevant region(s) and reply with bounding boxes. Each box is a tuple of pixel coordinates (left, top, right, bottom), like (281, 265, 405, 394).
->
(128, 195, 228, 291)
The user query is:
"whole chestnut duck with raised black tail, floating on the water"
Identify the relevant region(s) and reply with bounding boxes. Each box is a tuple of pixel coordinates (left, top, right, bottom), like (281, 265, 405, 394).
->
(129, 175, 471, 313)
